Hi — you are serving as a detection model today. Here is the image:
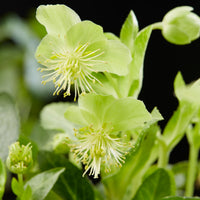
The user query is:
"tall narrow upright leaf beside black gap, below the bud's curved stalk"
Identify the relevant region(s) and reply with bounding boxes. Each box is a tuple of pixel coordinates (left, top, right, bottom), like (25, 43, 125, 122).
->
(118, 26, 152, 98)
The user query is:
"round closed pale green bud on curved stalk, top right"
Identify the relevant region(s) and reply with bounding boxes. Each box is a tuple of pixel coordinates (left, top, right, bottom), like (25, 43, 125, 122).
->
(162, 6, 200, 45)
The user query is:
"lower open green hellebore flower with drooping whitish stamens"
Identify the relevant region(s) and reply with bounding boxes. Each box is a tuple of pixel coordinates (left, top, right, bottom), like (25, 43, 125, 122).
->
(65, 94, 152, 178)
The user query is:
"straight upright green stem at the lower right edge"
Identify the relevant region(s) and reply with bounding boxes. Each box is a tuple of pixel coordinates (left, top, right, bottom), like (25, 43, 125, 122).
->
(185, 144, 199, 197)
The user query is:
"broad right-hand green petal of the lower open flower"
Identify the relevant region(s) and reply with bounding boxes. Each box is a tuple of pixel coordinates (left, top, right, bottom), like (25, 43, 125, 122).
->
(104, 97, 152, 130)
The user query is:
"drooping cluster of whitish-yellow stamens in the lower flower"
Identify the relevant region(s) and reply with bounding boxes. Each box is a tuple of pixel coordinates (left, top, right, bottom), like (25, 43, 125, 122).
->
(72, 125, 127, 178)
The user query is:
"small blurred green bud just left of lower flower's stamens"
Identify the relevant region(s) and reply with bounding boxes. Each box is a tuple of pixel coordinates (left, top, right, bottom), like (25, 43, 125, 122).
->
(53, 133, 70, 154)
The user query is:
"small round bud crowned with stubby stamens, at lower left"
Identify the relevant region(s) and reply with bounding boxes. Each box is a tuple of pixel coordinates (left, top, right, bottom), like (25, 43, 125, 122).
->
(6, 142, 33, 174)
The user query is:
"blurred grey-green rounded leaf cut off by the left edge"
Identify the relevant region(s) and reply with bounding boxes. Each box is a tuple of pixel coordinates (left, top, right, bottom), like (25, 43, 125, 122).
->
(0, 93, 20, 161)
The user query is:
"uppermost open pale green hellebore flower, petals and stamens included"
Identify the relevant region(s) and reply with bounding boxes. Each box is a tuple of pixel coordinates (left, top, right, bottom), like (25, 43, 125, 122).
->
(36, 5, 131, 99)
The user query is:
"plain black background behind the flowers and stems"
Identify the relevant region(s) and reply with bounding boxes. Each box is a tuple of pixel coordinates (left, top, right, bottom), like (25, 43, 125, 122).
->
(0, 0, 200, 162)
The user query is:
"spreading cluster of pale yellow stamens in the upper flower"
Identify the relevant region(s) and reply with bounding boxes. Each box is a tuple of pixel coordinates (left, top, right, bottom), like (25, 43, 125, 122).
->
(38, 43, 104, 100)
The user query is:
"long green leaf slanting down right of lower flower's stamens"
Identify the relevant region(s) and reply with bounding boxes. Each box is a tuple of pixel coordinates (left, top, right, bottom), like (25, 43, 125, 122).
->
(103, 125, 158, 200)
